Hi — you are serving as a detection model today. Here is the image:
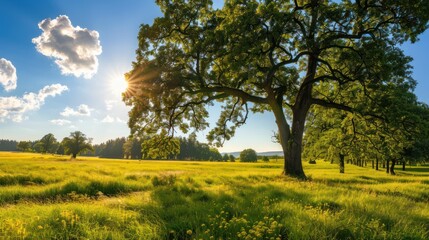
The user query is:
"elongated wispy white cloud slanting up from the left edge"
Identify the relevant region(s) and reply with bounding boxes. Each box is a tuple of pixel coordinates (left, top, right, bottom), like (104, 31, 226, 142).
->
(0, 84, 68, 122)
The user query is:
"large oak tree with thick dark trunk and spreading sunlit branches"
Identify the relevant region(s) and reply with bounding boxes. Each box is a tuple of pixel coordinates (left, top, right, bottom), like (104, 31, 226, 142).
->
(124, 0, 429, 177)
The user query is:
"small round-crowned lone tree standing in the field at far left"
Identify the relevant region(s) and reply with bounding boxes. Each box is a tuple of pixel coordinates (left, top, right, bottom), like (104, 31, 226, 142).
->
(61, 131, 93, 158)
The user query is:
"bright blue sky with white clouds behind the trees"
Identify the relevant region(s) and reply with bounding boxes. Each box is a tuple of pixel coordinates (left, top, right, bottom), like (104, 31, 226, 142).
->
(0, 0, 429, 152)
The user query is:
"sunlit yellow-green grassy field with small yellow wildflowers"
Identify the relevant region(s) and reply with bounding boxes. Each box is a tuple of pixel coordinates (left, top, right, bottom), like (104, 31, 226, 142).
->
(0, 152, 429, 239)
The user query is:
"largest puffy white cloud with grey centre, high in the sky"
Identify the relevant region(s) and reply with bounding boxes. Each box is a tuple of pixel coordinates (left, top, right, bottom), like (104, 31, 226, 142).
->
(32, 15, 102, 78)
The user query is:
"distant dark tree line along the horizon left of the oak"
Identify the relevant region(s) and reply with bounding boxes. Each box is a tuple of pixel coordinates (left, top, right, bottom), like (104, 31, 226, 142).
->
(5, 131, 231, 161)
